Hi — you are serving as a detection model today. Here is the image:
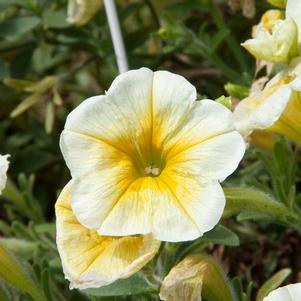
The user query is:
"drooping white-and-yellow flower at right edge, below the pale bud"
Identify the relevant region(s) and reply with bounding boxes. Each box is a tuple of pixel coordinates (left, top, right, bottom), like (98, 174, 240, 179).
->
(234, 61, 301, 143)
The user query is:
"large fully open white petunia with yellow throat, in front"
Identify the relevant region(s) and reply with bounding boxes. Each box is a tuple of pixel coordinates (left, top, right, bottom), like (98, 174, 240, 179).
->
(60, 68, 245, 241)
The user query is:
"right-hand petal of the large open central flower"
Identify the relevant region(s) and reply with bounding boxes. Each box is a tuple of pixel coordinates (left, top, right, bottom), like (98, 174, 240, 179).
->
(166, 100, 245, 181)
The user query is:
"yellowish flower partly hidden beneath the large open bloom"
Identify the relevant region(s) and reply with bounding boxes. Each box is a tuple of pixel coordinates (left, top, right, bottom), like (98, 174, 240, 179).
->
(55, 181, 160, 289)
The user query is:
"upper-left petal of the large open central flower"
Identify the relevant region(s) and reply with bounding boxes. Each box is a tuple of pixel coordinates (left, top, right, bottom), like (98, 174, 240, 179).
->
(65, 68, 153, 158)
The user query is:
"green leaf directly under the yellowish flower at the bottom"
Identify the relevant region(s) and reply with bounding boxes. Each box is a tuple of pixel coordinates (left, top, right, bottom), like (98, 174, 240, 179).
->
(84, 273, 156, 297)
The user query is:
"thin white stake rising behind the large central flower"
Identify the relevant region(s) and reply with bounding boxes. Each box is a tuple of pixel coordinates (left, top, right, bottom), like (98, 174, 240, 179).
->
(104, 0, 129, 73)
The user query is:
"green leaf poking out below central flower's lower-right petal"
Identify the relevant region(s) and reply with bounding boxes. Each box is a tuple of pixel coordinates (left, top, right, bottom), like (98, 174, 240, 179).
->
(201, 225, 239, 247)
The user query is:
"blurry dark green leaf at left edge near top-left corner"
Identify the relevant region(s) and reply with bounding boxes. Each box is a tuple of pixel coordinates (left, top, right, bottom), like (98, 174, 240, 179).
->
(0, 16, 40, 38)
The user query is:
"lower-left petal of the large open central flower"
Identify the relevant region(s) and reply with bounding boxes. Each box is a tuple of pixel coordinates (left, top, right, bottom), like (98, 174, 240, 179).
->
(61, 130, 135, 229)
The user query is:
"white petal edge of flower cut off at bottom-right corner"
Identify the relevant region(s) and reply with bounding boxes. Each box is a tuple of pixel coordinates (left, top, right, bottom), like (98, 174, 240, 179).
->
(263, 283, 301, 301)
